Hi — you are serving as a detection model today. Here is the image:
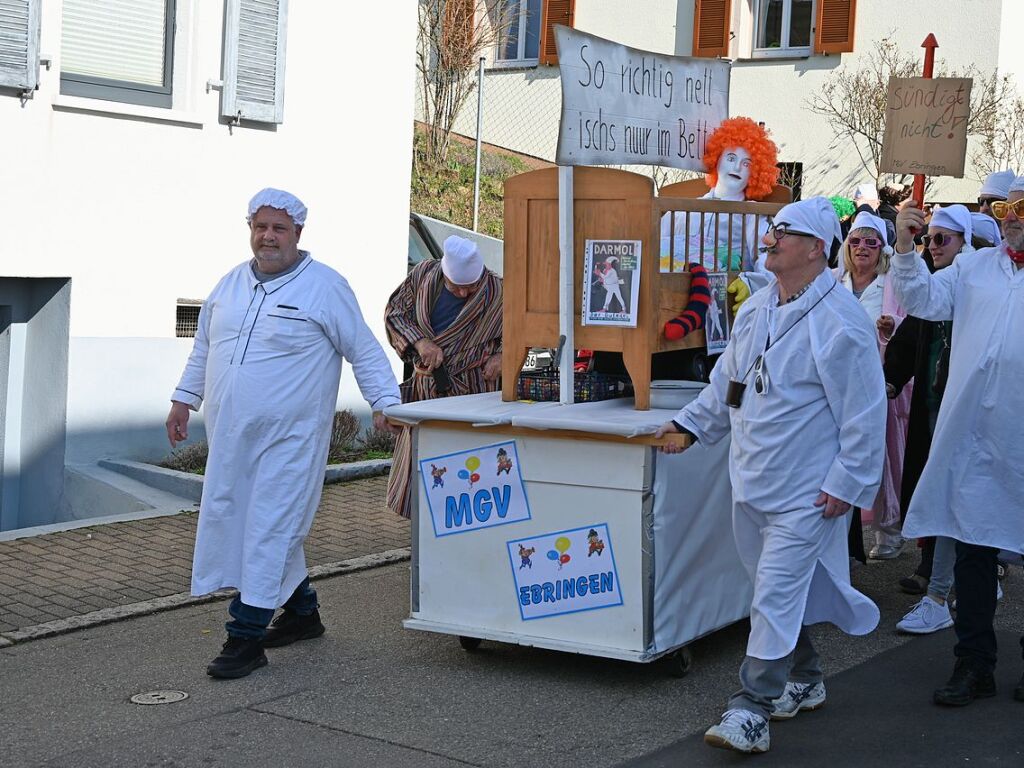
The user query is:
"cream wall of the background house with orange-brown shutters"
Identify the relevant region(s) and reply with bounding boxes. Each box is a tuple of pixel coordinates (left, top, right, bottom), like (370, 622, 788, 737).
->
(430, 0, 1007, 201)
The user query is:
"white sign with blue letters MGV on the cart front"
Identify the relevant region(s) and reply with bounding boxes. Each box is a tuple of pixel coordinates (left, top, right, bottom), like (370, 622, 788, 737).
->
(420, 440, 529, 537)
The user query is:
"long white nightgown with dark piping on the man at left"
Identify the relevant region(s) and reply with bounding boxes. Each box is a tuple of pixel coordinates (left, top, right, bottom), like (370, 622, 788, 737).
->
(172, 252, 400, 608)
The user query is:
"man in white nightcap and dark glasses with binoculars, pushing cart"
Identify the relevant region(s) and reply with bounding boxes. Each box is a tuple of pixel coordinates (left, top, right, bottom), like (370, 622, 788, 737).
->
(657, 198, 886, 753)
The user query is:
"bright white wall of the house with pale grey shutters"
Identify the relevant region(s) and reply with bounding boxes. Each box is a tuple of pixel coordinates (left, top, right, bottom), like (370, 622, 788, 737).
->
(0, 0, 416, 468)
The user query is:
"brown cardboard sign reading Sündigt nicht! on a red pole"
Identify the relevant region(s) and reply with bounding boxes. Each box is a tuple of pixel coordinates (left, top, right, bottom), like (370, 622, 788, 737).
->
(879, 77, 973, 178)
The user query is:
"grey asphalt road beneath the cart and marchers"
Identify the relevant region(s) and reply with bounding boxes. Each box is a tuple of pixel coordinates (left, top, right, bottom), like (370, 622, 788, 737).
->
(0, 551, 1024, 768)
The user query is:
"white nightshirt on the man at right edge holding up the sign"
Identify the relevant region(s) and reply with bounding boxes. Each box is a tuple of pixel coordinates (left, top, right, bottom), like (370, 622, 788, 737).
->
(890, 245, 1024, 552)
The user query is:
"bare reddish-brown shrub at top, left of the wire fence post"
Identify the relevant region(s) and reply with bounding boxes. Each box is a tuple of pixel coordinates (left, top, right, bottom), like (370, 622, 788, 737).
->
(416, 0, 514, 165)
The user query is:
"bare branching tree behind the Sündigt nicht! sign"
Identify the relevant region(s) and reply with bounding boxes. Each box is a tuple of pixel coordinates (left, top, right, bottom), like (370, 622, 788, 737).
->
(805, 38, 1024, 186)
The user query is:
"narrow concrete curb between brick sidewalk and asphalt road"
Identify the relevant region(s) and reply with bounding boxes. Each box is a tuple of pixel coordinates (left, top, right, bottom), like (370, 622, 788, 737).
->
(0, 547, 411, 648)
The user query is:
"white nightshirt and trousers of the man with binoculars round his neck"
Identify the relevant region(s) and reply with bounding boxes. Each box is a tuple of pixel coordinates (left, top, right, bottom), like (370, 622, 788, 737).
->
(676, 269, 886, 659)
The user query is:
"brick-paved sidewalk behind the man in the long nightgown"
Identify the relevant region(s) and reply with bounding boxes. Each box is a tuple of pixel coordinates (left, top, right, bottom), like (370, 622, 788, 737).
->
(0, 476, 409, 635)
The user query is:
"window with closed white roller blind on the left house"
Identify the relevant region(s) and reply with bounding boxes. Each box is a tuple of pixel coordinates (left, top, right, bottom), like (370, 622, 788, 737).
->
(60, 0, 175, 109)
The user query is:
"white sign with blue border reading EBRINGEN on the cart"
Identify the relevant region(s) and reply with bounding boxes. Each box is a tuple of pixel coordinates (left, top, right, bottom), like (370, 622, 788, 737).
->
(508, 522, 623, 622)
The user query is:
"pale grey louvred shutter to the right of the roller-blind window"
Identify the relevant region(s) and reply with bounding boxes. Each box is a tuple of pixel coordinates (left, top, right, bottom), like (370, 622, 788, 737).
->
(220, 0, 288, 123)
